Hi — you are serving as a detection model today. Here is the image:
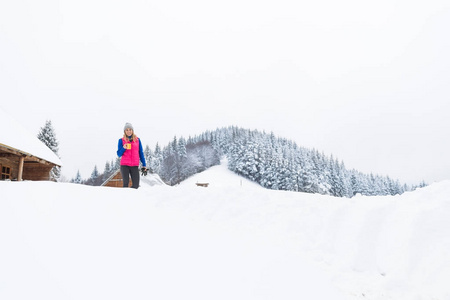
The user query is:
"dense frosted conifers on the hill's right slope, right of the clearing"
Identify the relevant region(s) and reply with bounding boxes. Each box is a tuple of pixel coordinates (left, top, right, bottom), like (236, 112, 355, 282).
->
(200, 127, 425, 197)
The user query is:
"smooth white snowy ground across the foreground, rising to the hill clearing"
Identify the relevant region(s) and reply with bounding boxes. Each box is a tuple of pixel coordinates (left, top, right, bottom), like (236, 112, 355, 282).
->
(0, 165, 450, 300)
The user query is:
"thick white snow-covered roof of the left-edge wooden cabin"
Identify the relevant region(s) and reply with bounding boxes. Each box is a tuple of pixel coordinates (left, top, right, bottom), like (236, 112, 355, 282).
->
(0, 108, 62, 166)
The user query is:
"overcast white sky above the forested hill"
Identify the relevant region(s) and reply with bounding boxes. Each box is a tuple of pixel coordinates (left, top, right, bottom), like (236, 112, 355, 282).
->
(0, 0, 450, 183)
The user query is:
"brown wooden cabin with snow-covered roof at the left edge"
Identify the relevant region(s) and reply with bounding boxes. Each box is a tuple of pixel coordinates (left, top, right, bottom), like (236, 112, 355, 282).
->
(0, 110, 62, 181)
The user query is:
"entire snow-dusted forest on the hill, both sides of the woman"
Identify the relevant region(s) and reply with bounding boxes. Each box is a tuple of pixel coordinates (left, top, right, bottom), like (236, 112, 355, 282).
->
(67, 126, 426, 197)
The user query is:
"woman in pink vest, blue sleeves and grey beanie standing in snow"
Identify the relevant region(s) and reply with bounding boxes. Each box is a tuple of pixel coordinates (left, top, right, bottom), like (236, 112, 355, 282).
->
(117, 123, 147, 189)
